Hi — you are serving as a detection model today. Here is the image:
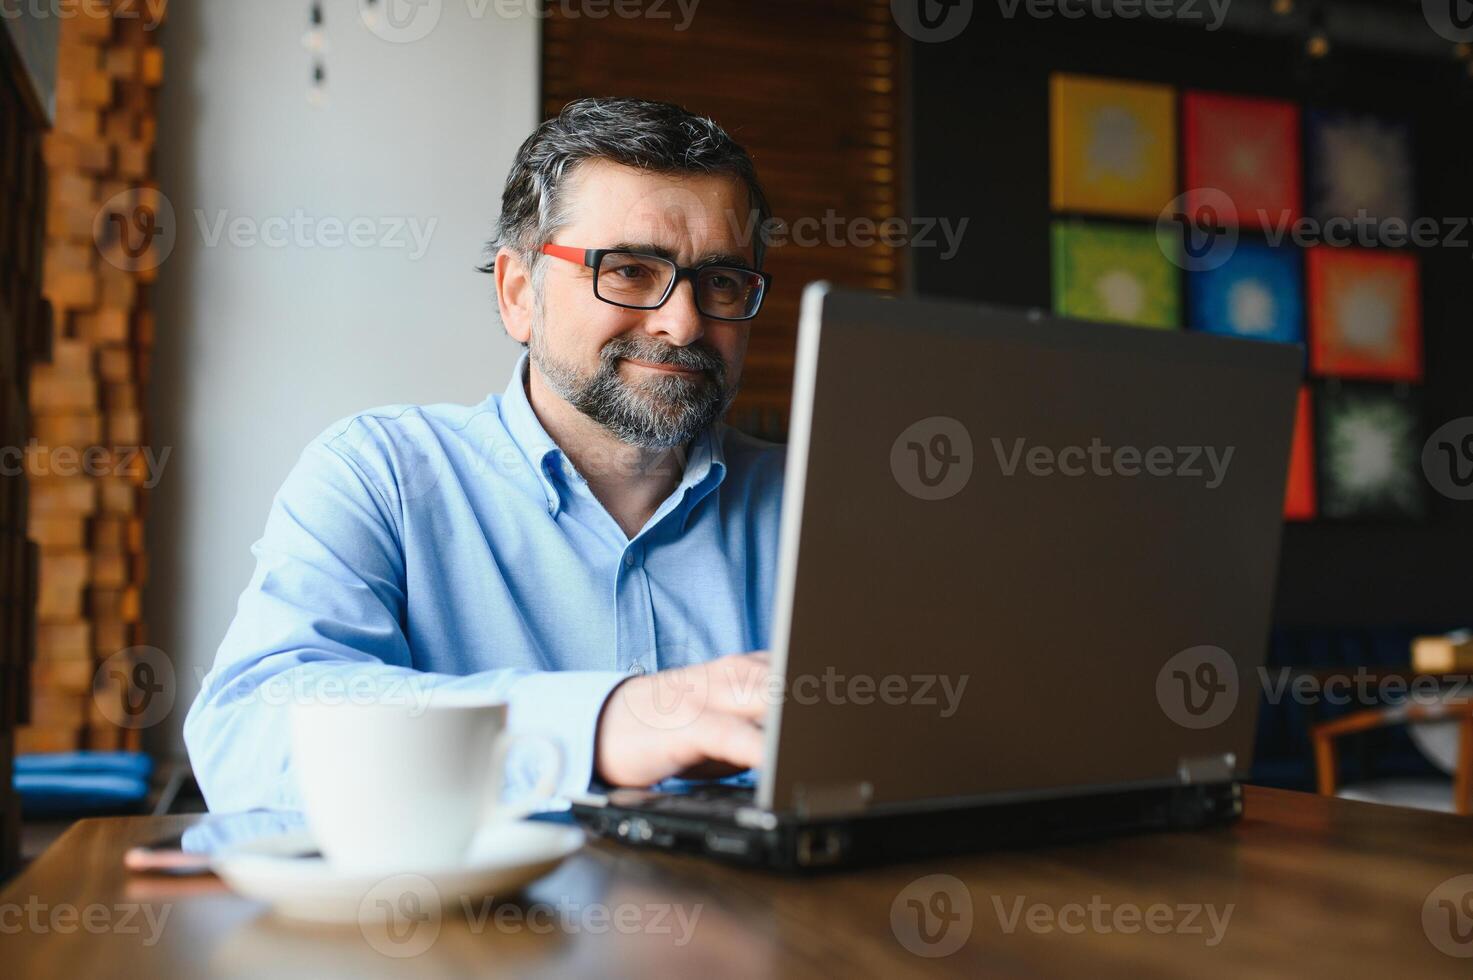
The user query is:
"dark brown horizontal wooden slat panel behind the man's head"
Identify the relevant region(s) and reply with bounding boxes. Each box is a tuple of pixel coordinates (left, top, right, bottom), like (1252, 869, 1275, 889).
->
(542, 0, 903, 438)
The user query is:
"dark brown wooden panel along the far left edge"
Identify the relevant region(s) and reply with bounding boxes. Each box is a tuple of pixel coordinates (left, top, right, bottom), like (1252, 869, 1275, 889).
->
(0, 26, 50, 878)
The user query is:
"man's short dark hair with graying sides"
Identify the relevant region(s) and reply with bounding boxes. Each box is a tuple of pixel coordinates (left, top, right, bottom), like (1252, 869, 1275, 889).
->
(480, 99, 772, 293)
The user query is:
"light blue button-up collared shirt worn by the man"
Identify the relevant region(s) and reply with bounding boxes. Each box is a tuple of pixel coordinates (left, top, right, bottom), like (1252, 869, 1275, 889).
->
(184, 355, 784, 811)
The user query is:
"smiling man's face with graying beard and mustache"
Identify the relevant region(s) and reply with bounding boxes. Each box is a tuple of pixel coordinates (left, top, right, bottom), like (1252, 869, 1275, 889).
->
(529, 161, 754, 449)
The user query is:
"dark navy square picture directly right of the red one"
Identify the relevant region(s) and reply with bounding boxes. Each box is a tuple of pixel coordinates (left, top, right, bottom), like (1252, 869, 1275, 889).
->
(1305, 112, 1416, 221)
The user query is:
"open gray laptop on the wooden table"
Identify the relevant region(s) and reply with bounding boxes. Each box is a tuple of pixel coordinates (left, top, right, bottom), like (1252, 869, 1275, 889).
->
(573, 283, 1304, 869)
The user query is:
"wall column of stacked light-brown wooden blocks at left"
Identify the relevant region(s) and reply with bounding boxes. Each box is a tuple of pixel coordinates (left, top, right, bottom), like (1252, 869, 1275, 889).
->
(19, 9, 164, 752)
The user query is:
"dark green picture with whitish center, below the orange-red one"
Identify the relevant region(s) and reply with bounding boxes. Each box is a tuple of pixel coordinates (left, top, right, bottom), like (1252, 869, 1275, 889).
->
(1314, 382, 1427, 520)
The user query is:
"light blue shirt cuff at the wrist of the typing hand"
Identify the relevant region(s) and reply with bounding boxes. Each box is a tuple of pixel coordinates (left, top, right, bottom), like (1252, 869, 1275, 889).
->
(508, 671, 629, 808)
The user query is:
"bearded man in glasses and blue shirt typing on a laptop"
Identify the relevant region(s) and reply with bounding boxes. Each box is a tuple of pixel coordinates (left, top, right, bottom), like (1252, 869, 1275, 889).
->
(184, 99, 782, 811)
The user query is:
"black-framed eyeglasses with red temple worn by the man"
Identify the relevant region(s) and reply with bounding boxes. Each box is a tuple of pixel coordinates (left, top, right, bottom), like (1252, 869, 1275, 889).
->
(542, 245, 772, 320)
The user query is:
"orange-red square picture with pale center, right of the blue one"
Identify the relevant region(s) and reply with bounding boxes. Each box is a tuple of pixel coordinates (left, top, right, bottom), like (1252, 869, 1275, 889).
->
(1305, 245, 1421, 382)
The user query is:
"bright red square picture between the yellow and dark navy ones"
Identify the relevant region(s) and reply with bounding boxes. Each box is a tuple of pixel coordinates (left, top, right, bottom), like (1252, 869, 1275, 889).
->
(1181, 91, 1302, 228)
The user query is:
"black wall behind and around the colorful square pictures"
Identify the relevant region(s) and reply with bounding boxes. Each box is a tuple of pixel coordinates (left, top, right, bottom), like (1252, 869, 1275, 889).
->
(909, 4, 1473, 628)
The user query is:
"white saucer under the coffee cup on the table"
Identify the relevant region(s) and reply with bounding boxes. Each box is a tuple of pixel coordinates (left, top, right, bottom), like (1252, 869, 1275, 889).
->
(211, 821, 586, 923)
